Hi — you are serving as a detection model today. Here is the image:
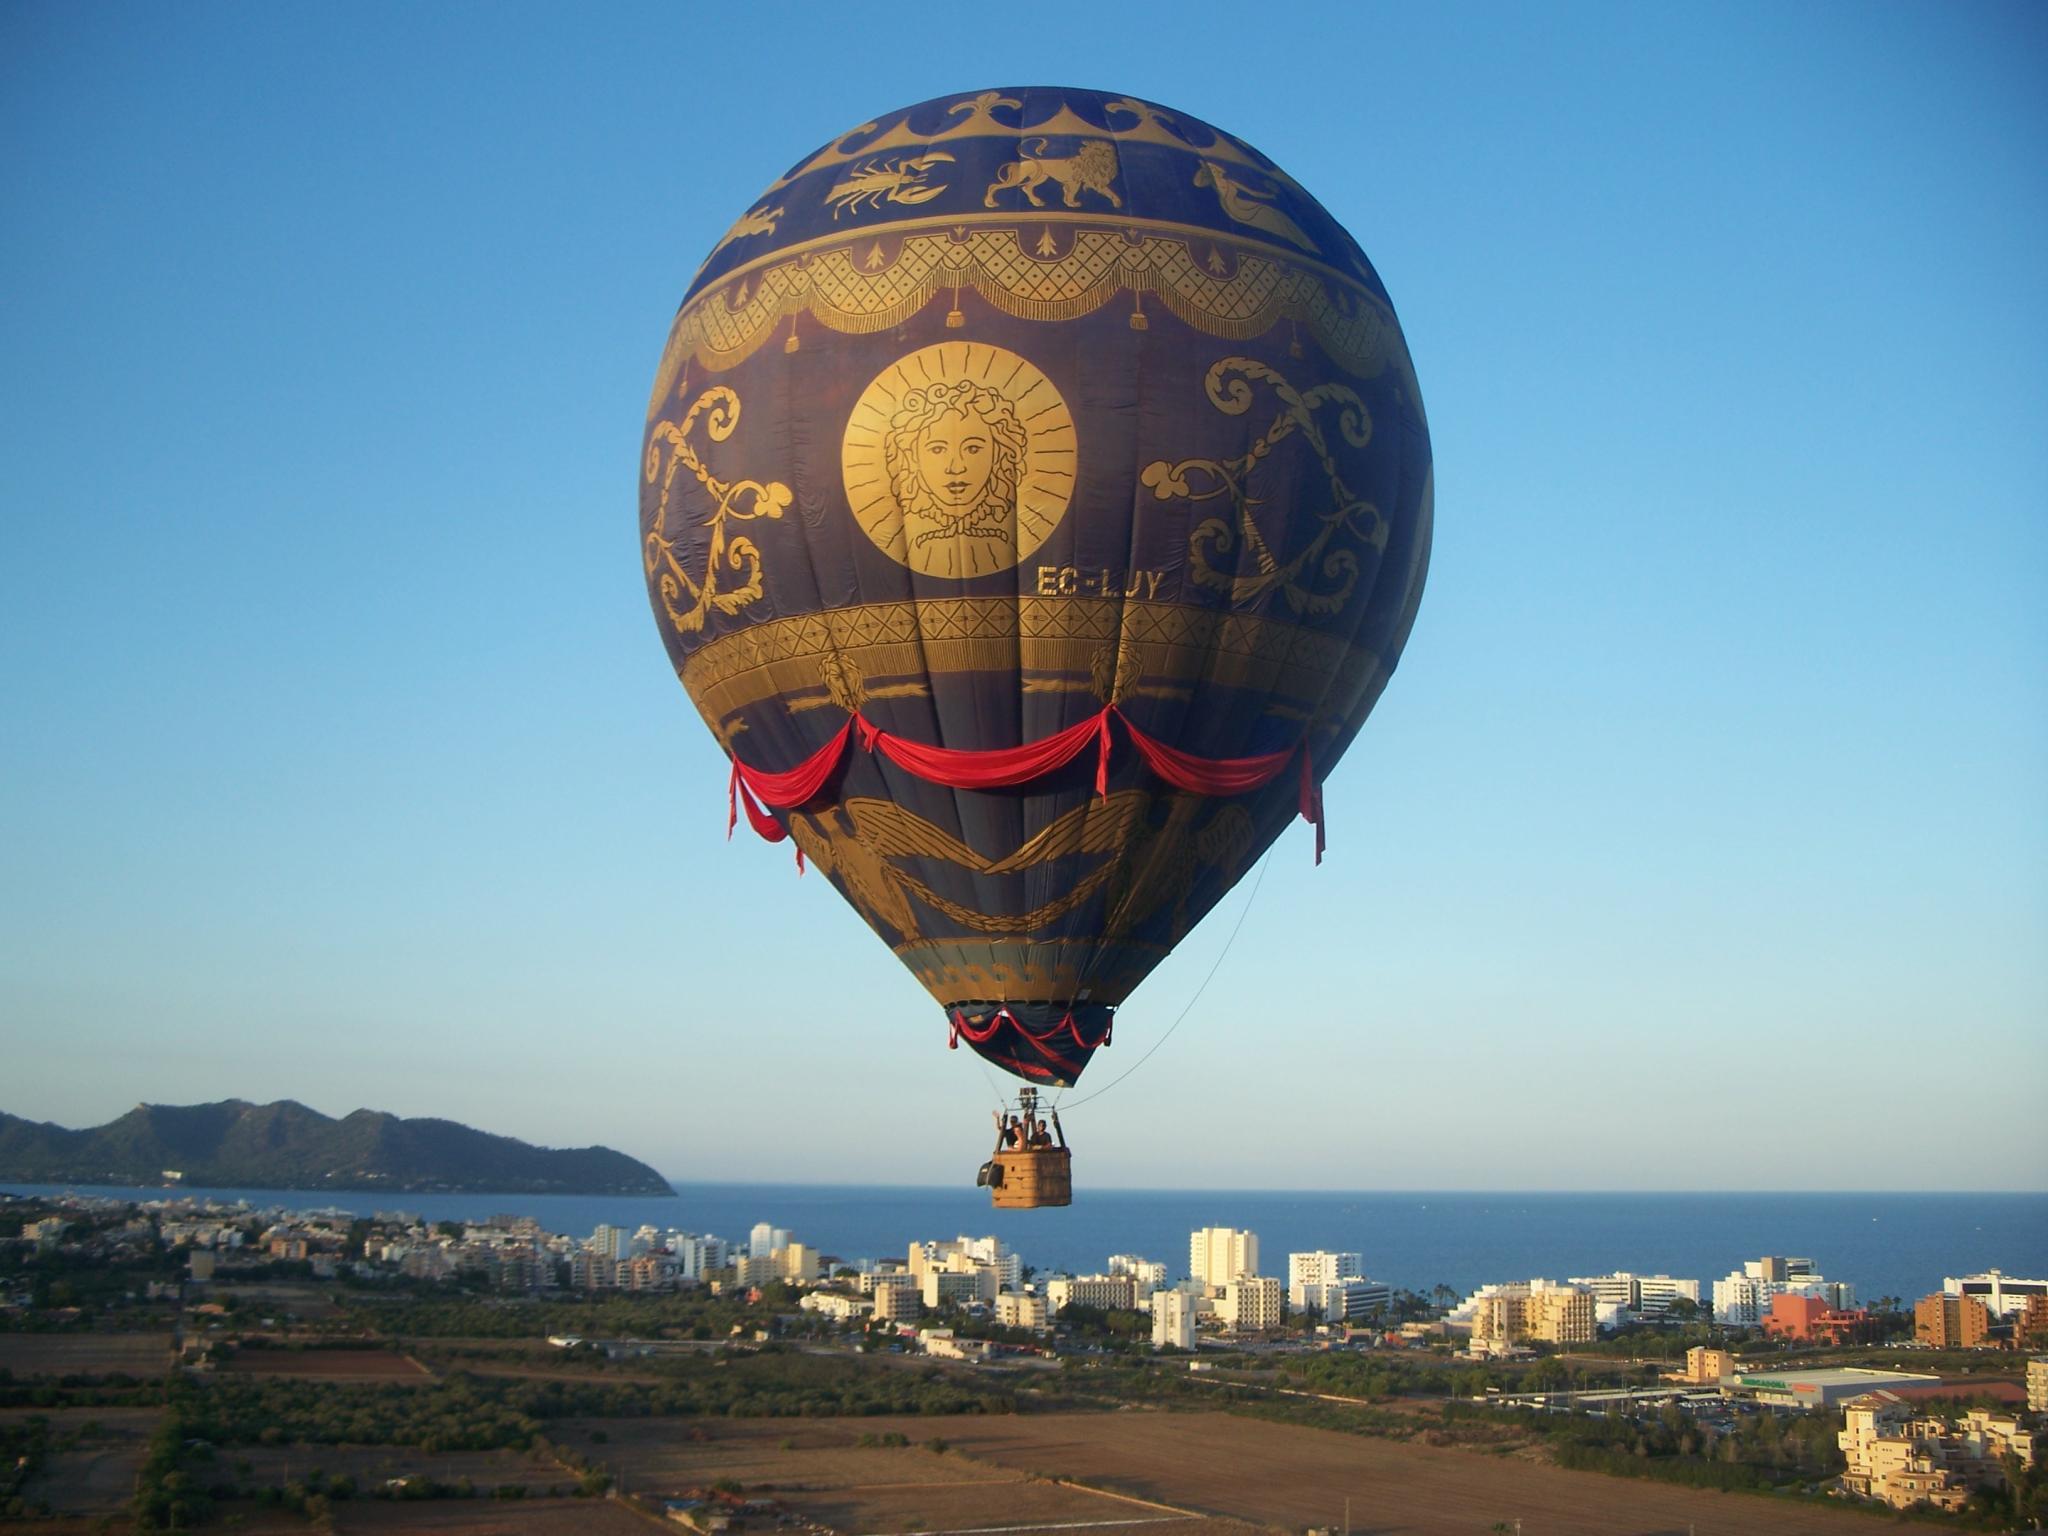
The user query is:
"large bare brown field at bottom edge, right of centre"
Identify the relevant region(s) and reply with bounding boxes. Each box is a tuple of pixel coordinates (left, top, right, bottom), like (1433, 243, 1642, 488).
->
(839, 1409, 1870, 1536)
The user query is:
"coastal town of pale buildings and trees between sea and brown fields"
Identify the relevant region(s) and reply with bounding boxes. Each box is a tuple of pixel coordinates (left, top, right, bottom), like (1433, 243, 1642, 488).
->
(0, 1194, 2048, 1518)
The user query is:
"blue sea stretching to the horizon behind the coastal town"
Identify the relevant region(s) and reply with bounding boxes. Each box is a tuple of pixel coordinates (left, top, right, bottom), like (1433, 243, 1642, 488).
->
(0, 1184, 2048, 1303)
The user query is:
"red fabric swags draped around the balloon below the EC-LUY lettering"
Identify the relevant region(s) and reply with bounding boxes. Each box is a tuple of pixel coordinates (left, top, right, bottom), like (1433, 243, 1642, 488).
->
(725, 705, 1325, 860)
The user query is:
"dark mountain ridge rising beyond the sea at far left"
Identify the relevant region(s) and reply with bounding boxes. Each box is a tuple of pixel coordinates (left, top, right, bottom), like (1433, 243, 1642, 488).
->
(0, 1098, 674, 1194)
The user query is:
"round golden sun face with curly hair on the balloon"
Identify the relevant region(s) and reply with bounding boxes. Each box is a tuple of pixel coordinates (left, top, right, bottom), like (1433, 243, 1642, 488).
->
(840, 342, 1077, 580)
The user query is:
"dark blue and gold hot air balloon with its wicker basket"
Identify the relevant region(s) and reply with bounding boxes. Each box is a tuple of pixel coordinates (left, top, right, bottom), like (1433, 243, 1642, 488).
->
(641, 86, 1434, 1204)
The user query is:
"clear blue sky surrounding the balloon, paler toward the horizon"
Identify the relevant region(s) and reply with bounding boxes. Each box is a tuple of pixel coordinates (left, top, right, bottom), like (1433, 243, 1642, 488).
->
(0, 0, 2048, 1190)
